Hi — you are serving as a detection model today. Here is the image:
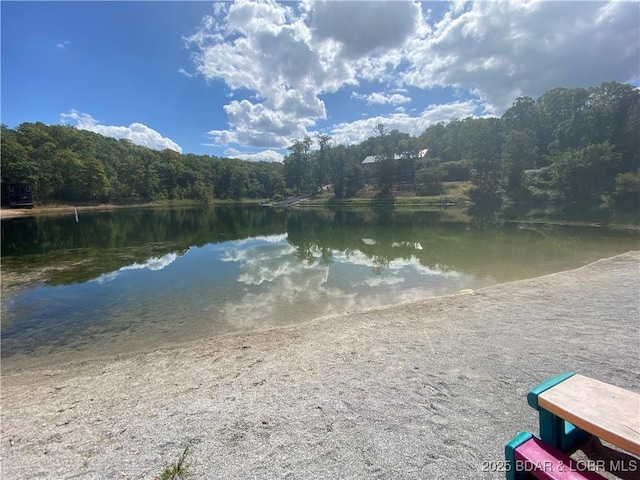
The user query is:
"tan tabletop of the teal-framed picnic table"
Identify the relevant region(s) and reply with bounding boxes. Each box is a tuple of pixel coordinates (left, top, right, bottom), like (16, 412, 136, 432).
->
(538, 375, 640, 455)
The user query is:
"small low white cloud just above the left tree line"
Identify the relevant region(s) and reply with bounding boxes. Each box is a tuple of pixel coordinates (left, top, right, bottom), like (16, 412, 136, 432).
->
(60, 110, 182, 153)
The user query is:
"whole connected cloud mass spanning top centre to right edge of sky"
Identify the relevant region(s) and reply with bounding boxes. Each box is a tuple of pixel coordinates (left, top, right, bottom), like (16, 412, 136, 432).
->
(185, 0, 640, 149)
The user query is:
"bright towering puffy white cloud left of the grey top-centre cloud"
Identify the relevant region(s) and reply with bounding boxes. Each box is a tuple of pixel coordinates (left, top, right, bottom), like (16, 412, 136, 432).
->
(185, 1, 353, 149)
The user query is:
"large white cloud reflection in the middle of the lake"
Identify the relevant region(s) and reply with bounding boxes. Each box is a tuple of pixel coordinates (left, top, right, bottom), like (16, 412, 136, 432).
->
(221, 232, 468, 328)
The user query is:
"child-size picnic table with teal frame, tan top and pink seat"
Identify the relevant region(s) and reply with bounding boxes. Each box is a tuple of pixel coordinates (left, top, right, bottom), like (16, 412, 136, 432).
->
(505, 372, 640, 480)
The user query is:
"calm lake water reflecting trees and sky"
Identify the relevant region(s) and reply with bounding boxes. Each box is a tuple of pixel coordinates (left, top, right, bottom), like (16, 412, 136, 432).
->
(1, 207, 640, 371)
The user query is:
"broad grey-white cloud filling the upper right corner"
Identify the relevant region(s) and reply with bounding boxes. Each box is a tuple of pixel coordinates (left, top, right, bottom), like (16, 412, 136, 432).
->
(401, 0, 640, 115)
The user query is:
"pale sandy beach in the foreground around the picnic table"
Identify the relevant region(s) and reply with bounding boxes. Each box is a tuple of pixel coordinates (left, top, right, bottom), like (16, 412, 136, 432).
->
(1, 252, 640, 480)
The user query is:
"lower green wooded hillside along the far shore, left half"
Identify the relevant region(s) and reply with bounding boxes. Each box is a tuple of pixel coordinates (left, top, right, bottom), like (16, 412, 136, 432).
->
(1, 122, 284, 203)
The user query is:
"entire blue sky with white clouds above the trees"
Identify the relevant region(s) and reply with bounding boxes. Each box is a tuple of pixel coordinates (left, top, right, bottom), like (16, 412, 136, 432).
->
(0, 0, 640, 160)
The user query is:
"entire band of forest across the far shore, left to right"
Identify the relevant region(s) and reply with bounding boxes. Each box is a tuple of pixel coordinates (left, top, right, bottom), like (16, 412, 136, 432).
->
(1, 82, 640, 215)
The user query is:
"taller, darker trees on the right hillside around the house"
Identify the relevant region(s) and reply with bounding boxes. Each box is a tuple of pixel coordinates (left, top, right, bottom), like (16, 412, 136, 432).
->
(284, 82, 640, 212)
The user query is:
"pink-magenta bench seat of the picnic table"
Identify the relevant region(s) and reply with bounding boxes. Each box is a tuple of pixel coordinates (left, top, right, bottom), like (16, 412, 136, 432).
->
(512, 437, 604, 480)
